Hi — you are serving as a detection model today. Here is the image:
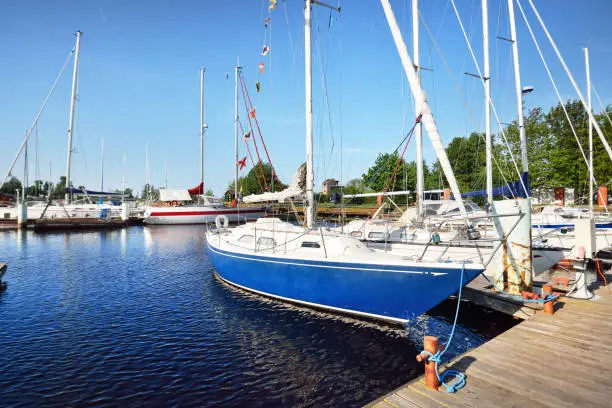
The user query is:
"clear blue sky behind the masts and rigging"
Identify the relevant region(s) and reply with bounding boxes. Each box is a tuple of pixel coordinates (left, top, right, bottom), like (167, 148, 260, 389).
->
(0, 0, 612, 195)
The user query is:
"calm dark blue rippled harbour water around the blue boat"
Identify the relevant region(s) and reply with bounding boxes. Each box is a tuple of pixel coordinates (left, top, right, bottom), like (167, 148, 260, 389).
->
(0, 226, 513, 407)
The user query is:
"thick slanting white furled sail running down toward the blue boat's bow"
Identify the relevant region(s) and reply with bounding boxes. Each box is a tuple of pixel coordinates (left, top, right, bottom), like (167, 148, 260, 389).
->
(381, 0, 467, 217)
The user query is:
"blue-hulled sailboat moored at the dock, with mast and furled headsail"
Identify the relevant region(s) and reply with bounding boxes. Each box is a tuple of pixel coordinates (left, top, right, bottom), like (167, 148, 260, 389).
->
(206, 0, 484, 324)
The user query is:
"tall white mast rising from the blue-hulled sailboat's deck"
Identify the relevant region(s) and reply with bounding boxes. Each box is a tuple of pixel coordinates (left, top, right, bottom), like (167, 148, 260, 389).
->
(304, 0, 315, 228)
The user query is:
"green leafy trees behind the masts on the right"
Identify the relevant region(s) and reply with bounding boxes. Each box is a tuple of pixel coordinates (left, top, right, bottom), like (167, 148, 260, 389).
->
(344, 100, 612, 206)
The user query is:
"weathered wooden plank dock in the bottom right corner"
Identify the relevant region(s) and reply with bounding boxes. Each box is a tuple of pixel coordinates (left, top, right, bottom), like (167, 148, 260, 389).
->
(368, 273, 612, 408)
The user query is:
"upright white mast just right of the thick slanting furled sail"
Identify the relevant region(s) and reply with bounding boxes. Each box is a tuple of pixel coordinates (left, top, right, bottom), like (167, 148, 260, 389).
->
(482, 0, 493, 208)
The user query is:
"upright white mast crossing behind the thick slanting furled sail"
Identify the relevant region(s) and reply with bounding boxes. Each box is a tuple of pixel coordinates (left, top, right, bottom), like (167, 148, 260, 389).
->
(412, 0, 425, 219)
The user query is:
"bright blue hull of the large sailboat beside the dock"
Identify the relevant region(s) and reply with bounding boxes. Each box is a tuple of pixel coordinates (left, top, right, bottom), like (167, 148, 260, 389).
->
(207, 243, 481, 324)
